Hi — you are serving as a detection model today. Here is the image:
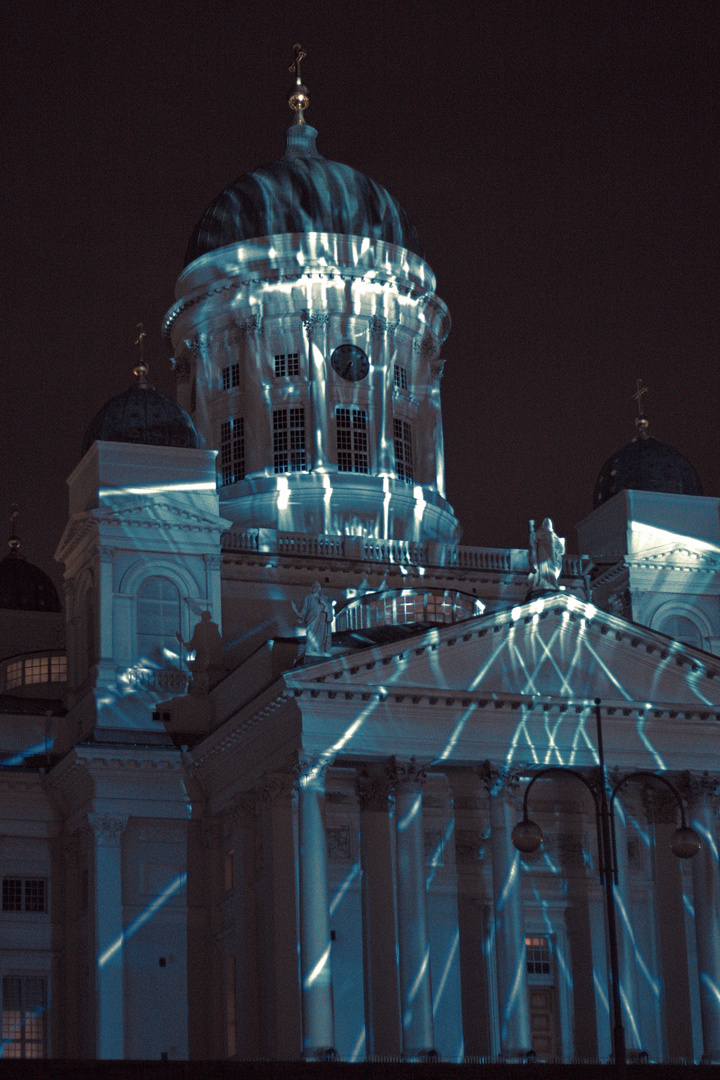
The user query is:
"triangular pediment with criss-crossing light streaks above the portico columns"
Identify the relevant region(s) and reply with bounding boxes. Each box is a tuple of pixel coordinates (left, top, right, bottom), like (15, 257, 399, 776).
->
(288, 593, 720, 708)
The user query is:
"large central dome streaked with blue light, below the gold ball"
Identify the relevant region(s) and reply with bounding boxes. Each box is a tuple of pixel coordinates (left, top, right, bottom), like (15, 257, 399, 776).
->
(185, 123, 422, 266)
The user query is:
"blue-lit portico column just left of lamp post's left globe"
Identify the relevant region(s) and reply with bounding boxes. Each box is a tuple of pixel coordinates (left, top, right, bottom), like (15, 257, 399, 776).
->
(490, 786, 532, 1057)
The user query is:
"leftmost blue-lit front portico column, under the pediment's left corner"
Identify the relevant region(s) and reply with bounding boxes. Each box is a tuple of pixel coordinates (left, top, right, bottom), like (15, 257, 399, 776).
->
(298, 766, 335, 1058)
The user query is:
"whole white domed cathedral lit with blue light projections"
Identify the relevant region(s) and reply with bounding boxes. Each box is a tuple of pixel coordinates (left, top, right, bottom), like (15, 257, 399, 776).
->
(0, 58, 720, 1062)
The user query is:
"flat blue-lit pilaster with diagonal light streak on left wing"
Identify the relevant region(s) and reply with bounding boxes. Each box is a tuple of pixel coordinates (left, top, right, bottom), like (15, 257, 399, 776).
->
(87, 813, 127, 1059)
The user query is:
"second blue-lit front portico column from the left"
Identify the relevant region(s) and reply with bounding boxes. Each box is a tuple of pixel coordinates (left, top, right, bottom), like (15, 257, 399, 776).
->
(390, 758, 436, 1059)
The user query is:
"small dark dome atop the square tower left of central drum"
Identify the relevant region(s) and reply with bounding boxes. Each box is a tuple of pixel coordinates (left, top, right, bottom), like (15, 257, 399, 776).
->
(81, 364, 200, 457)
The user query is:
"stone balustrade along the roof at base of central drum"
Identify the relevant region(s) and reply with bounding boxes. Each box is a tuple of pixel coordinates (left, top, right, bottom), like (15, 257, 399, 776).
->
(222, 529, 587, 577)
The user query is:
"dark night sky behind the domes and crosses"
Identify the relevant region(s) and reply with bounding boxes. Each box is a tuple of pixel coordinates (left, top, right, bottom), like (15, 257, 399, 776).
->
(0, 0, 720, 582)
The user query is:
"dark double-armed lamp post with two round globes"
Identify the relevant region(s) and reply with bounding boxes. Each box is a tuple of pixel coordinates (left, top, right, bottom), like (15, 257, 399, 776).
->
(511, 698, 701, 1080)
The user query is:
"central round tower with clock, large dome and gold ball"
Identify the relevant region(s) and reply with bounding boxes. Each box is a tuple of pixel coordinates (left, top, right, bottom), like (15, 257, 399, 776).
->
(165, 65, 459, 542)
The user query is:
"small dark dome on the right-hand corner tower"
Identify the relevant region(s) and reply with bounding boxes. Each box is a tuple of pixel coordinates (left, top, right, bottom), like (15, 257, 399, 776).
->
(593, 430, 703, 508)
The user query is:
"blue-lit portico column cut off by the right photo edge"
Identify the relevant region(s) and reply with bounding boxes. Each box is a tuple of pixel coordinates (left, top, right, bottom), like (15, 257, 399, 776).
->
(691, 795, 720, 1062)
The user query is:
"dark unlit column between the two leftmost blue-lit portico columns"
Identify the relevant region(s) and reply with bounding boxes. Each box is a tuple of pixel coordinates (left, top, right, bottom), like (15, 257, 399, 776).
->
(357, 772, 402, 1057)
